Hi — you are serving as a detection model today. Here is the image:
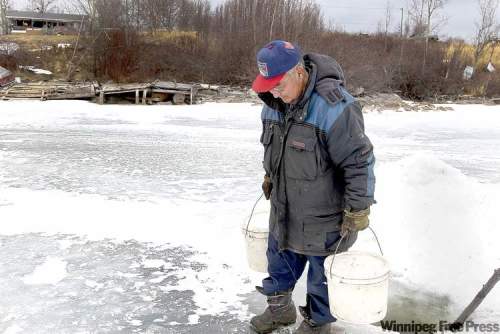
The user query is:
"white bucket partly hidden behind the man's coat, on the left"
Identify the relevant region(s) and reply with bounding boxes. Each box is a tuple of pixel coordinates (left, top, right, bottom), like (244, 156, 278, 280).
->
(242, 197, 271, 273)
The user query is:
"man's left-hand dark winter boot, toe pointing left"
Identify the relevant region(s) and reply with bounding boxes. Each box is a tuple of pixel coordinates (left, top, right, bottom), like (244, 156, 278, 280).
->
(250, 287, 297, 334)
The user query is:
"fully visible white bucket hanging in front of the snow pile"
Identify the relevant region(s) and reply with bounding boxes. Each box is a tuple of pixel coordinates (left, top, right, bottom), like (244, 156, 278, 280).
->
(324, 251, 389, 325)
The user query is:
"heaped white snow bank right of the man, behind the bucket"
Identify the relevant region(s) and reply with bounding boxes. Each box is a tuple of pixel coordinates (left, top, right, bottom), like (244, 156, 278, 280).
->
(355, 154, 500, 310)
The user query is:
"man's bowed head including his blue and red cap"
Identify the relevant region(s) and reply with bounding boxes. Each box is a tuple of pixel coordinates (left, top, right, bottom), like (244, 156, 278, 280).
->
(252, 40, 308, 103)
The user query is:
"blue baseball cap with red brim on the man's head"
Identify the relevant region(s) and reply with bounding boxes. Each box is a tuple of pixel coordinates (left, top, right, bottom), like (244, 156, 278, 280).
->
(252, 40, 302, 93)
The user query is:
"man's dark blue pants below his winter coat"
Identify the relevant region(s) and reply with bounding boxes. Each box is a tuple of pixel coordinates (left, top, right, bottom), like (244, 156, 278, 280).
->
(262, 234, 336, 325)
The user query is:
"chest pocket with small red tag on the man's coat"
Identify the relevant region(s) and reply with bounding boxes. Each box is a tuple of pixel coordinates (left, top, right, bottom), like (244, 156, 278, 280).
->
(285, 137, 318, 180)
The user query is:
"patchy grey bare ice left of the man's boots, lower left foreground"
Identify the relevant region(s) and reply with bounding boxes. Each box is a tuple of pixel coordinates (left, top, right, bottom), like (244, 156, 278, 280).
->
(0, 233, 245, 333)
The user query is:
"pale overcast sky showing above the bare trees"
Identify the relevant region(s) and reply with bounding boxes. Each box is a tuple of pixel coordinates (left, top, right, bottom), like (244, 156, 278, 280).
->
(8, 0, 500, 40)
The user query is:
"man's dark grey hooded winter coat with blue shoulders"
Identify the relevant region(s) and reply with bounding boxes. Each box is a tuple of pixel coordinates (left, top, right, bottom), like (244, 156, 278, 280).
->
(259, 53, 375, 256)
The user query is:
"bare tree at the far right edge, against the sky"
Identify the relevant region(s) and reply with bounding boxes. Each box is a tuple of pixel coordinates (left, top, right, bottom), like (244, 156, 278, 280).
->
(474, 0, 500, 66)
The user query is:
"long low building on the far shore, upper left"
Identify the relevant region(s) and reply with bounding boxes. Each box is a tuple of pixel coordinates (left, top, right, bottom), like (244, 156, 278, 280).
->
(5, 10, 85, 34)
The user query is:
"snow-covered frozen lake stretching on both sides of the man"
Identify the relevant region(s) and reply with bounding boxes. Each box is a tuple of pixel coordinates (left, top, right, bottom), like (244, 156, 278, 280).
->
(0, 101, 500, 333)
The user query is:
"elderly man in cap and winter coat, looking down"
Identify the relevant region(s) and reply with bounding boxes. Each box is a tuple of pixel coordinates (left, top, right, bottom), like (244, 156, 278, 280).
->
(251, 40, 375, 334)
